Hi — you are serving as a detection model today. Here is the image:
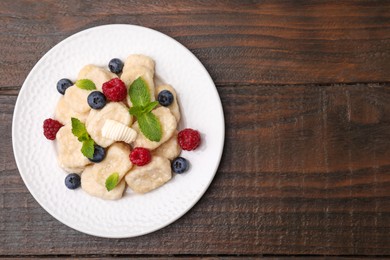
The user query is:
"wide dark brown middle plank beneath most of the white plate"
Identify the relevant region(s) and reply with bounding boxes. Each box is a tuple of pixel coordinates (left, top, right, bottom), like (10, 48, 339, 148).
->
(0, 84, 390, 256)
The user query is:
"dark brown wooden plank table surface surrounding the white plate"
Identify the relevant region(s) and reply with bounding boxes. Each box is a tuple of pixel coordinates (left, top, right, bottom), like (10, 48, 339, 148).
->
(0, 0, 390, 257)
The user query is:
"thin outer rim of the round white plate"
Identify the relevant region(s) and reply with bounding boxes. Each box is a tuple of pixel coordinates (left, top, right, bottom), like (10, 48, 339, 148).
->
(12, 24, 226, 238)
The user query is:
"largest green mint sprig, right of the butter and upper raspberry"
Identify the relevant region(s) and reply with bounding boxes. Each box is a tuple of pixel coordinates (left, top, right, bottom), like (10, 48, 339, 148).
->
(128, 77, 162, 142)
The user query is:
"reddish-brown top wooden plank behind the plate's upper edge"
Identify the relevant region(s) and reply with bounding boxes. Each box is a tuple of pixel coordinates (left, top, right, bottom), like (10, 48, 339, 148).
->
(0, 0, 390, 87)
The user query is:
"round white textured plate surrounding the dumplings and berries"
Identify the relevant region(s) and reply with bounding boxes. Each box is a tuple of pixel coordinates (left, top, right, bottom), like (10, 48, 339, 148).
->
(12, 25, 225, 238)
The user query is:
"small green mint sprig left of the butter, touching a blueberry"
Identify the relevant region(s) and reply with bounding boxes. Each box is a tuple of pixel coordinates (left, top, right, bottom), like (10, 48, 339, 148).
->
(71, 117, 95, 159)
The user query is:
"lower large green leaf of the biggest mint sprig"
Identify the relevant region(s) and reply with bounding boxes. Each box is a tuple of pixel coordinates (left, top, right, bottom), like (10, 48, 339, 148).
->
(137, 112, 162, 142)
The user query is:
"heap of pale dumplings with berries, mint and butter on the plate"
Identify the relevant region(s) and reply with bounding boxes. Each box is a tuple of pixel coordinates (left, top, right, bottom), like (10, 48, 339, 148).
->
(43, 54, 201, 200)
